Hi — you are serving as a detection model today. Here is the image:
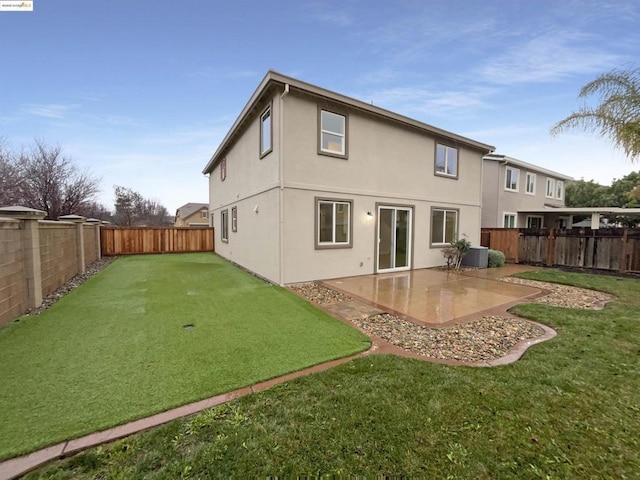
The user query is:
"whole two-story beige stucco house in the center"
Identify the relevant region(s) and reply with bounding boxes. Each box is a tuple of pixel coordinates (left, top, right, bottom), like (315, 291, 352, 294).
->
(203, 71, 493, 284)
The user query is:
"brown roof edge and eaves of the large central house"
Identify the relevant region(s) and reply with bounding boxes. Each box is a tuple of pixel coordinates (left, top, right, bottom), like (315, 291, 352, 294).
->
(202, 70, 495, 174)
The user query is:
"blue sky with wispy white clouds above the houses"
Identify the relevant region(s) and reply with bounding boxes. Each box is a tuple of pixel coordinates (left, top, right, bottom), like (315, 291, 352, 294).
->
(0, 0, 640, 211)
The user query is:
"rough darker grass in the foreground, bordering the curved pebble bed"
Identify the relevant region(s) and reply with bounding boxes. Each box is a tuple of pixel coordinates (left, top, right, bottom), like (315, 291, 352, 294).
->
(21, 271, 640, 479)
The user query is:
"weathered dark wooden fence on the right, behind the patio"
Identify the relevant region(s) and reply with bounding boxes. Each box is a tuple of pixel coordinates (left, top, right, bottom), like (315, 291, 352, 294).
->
(481, 228, 640, 273)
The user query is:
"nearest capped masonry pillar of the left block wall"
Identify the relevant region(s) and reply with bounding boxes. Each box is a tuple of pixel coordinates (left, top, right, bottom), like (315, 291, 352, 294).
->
(0, 206, 47, 308)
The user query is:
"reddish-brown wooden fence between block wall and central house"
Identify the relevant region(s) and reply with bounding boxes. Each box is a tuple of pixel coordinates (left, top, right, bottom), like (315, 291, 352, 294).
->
(100, 226, 215, 255)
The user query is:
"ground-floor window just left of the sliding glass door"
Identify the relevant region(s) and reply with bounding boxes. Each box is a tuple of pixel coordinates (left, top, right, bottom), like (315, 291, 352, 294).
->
(316, 199, 351, 248)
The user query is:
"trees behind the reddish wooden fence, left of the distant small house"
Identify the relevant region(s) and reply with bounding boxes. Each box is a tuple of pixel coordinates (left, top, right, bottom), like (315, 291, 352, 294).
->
(113, 185, 173, 226)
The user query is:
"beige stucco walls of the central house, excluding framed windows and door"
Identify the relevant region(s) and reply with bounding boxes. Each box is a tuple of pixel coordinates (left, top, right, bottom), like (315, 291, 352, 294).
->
(209, 86, 486, 283)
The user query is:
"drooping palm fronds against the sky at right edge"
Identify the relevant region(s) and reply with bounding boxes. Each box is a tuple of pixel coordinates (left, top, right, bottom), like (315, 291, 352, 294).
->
(551, 68, 640, 162)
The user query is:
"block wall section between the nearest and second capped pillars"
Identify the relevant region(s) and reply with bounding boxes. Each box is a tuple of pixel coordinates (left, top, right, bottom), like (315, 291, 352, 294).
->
(39, 220, 78, 296)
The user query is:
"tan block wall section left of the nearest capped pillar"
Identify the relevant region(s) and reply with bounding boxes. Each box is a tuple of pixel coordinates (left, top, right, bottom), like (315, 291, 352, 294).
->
(0, 218, 27, 326)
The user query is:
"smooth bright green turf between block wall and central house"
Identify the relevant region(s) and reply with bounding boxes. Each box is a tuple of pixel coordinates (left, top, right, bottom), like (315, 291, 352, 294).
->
(0, 254, 369, 459)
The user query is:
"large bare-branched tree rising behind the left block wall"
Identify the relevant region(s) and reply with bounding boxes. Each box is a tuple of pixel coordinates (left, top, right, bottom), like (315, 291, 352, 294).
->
(0, 140, 100, 220)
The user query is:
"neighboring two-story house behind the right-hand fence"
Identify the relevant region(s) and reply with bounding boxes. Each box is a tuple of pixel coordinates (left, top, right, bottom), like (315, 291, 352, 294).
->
(482, 153, 573, 228)
